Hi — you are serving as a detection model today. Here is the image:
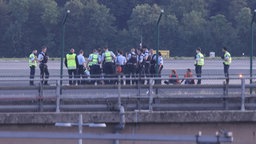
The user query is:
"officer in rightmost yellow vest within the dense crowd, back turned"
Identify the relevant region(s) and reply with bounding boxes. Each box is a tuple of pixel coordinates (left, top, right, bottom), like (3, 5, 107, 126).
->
(102, 47, 116, 84)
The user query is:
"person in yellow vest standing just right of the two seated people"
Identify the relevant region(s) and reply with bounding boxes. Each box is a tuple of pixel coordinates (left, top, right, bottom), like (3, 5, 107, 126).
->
(195, 48, 204, 84)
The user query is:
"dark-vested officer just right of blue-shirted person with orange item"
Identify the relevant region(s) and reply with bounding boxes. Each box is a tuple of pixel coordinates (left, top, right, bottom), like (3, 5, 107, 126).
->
(126, 48, 138, 84)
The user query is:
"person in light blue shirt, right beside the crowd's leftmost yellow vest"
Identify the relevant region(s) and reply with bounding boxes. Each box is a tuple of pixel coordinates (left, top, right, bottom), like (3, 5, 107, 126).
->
(77, 50, 86, 85)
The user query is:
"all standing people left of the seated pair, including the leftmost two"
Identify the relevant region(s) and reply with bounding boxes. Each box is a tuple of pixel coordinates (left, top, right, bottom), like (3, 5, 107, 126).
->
(29, 46, 163, 85)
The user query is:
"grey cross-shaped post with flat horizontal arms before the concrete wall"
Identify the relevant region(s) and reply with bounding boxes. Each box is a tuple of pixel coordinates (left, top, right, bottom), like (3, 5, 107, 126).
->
(55, 114, 107, 144)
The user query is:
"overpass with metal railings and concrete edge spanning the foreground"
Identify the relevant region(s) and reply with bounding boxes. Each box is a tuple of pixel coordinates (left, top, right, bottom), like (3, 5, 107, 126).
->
(0, 59, 256, 144)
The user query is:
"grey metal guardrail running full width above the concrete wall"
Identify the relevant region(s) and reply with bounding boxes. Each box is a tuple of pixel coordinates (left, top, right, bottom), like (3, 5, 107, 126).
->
(0, 76, 256, 112)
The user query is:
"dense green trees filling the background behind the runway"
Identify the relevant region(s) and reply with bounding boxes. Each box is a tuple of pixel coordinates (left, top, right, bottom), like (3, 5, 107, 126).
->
(0, 0, 256, 57)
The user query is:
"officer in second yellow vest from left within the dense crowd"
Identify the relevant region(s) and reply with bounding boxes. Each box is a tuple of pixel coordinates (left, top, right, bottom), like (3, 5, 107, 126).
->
(88, 49, 101, 83)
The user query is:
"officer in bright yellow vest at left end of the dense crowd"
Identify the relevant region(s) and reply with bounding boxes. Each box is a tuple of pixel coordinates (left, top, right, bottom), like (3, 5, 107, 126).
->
(65, 48, 78, 85)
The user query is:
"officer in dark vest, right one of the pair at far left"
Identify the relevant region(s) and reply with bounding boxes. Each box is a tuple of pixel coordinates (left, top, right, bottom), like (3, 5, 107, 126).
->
(37, 46, 50, 85)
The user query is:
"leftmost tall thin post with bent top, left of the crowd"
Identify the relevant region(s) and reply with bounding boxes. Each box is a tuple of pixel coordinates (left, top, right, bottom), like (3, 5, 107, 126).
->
(60, 10, 70, 85)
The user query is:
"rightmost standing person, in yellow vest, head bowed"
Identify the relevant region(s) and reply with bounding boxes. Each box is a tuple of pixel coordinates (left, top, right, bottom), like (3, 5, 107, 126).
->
(221, 47, 232, 84)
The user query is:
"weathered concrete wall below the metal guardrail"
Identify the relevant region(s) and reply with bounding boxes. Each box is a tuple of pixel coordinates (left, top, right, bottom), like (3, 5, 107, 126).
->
(0, 111, 256, 144)
